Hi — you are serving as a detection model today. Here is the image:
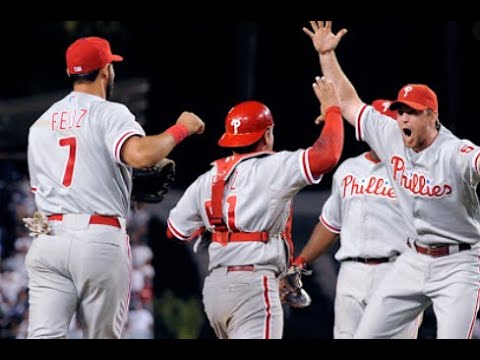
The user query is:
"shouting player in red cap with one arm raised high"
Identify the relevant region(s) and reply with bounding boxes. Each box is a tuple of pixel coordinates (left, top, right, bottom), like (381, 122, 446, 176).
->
(304, 21, 480, 339)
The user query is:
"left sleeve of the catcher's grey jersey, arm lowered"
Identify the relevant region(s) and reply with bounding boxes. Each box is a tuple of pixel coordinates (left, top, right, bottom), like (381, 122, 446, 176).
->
(167, 179, 205, 241)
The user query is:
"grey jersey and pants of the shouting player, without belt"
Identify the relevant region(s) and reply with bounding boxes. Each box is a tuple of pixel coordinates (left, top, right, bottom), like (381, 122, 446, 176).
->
(355, 106, 480, 339)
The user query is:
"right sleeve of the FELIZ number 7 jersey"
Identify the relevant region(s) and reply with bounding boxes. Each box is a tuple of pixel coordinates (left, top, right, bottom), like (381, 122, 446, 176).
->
(100, 102, 145, 164)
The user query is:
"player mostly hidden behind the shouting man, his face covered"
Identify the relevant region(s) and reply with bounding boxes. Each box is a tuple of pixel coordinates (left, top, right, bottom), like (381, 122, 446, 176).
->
(299, 100, 419, 339)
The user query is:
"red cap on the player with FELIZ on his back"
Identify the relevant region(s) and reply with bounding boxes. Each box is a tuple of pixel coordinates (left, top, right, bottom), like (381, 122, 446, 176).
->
(66, 36, 123, 75)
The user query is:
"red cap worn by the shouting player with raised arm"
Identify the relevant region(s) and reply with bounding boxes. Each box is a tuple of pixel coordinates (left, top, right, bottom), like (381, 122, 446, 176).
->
(390, 84, 438, 112)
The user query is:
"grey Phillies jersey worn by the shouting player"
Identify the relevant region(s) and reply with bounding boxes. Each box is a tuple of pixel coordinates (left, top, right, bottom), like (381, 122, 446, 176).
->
(356, 106, 480, 245)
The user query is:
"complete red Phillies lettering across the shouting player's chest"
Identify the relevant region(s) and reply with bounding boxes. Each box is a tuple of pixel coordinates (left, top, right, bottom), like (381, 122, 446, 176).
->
(391, 156, 453, 198)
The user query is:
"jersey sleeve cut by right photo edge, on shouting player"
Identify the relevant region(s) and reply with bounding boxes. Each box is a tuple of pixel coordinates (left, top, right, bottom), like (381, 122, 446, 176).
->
(453, 140, 480, 186)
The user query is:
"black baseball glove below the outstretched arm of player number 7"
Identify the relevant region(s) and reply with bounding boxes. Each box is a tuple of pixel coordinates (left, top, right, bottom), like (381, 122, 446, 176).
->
(132, 158, 175, 204)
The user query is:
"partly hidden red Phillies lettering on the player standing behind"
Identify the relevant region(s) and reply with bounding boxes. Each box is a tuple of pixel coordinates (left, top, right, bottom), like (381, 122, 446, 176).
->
(342, 175, 396, 199)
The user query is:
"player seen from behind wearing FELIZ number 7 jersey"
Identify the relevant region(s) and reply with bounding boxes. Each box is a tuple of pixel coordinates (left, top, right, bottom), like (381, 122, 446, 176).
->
(26, 37, 204, 338)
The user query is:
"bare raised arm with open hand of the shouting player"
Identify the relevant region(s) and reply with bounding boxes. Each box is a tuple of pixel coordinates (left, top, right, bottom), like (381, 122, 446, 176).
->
(303, 21, 364, 126)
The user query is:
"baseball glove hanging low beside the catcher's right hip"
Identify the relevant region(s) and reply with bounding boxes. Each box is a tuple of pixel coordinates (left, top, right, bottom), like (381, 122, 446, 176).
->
(280, 265, 312, 309)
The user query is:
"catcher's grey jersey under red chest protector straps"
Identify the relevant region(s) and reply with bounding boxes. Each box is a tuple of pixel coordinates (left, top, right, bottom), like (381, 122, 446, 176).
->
(168, 150, 321, 271)
